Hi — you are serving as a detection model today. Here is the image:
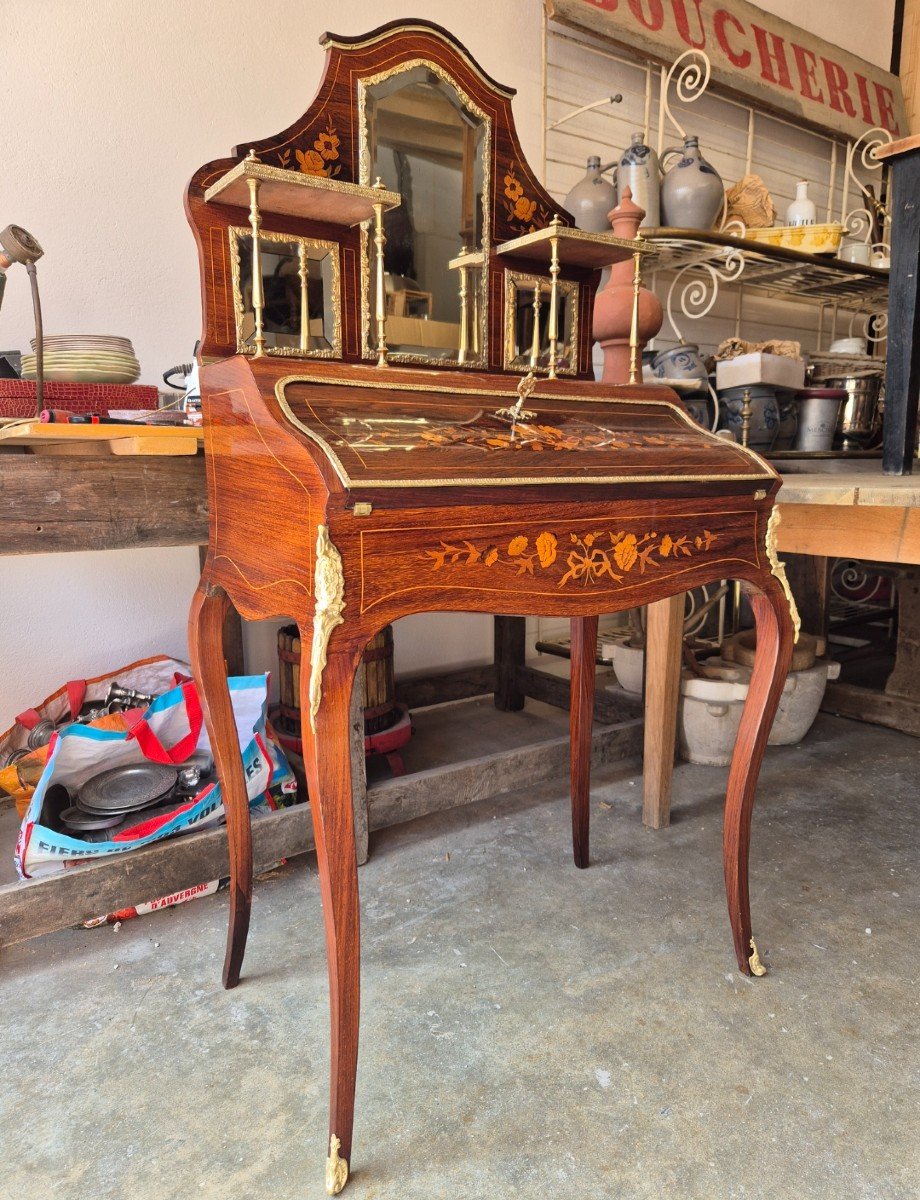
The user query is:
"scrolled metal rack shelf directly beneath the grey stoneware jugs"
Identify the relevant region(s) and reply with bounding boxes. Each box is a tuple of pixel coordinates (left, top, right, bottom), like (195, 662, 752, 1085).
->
(639, 228, 888, 312)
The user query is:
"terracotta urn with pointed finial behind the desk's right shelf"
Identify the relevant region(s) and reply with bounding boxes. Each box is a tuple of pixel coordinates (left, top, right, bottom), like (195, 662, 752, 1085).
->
(593, 187, 663, 383)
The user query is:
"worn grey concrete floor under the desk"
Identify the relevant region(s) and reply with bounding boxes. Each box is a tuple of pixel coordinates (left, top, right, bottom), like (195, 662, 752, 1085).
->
(0, 718, 920, 1200)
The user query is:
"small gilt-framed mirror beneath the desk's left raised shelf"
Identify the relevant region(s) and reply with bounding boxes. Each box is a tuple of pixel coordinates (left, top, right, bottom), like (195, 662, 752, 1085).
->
(230, 228, 342, 358)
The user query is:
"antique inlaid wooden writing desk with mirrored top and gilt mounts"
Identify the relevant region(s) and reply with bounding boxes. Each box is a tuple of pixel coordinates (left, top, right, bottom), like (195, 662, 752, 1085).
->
(188, 22, 793, 1193)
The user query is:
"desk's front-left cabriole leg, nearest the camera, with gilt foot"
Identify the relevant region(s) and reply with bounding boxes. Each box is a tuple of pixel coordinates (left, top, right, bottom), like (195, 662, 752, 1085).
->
(300, 647, 363, 1195)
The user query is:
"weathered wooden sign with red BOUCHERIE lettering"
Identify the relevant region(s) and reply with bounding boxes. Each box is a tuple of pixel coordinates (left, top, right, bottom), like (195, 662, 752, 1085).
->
(546, 0, 908, 139)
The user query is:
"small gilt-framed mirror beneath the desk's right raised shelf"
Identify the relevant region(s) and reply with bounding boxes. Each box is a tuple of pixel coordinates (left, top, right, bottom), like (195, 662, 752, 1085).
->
(503, 271, 578, 374)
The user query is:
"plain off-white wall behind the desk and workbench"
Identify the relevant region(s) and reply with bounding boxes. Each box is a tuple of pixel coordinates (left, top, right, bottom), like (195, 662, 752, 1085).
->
(0, 0, 892, 728)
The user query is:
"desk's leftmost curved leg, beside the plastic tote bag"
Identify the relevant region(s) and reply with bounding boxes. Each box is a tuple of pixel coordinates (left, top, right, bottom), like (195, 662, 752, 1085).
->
(188, 580, 252, 988)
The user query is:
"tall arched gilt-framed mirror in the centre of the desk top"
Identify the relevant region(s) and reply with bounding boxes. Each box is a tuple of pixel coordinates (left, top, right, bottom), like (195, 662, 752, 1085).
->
(359, 60, 492, 366)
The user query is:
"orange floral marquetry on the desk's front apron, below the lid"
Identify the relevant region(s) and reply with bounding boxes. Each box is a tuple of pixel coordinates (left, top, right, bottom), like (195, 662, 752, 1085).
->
(421, 529, 716, 588)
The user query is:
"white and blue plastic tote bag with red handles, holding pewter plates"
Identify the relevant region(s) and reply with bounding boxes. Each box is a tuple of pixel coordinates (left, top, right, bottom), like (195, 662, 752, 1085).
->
(16, 676, 296, 878)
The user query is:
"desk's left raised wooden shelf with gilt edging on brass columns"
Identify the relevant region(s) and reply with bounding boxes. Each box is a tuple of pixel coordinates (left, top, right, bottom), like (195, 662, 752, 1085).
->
(204, 158, 402, 226)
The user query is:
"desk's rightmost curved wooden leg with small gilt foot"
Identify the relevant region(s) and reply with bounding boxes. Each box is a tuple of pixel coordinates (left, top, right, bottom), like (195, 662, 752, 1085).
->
(722, 581, 793, 974)
